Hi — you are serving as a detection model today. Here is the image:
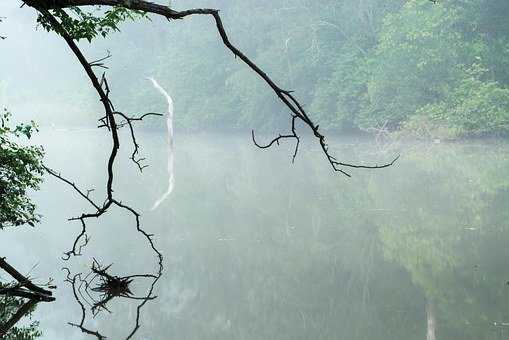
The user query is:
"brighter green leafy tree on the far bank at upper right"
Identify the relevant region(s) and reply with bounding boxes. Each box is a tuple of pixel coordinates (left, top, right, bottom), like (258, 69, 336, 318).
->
(360, 0, 509, 135)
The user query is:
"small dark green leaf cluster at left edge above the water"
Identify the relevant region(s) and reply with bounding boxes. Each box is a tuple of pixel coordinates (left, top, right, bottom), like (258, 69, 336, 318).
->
(0, 110, 44, 229)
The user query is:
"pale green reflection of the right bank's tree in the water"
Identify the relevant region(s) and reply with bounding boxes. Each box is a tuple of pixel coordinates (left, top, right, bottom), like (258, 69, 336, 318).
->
(372, 145, 509, 339)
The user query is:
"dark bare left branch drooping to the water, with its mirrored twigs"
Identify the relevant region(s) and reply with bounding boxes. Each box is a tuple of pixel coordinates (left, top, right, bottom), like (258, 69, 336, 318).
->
(25, 2, 163, 340)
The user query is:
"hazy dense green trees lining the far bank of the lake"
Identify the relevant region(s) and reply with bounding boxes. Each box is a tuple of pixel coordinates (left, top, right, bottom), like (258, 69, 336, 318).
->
(90, 0, 509, 137)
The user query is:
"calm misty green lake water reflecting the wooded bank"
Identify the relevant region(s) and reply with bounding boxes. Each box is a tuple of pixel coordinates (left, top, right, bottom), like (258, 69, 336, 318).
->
(0, 131, 509, 340)
